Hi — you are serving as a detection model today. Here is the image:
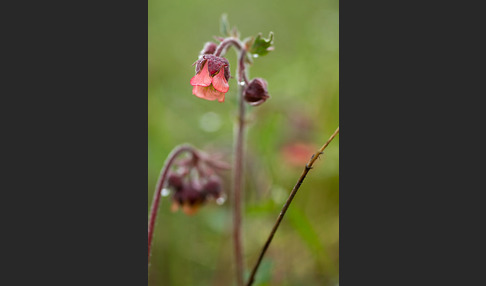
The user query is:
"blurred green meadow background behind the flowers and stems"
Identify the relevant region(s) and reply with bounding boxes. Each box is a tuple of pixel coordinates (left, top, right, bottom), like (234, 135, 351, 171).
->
(147, 0, 339, 286)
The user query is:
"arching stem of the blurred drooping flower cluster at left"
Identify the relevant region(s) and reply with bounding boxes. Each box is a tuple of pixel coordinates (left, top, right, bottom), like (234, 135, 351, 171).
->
(148, 145, 198, 263)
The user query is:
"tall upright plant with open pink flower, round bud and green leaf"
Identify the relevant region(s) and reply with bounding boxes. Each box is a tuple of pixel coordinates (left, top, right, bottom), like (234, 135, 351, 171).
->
(190, 15, 273, 286)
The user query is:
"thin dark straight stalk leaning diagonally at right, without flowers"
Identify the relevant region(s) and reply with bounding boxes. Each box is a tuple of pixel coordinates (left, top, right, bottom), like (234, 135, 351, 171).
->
(246, 127, 339, 286)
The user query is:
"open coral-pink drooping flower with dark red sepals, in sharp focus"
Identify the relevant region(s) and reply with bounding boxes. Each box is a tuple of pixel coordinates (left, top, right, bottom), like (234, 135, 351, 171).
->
(191, 54, 231, 102)
